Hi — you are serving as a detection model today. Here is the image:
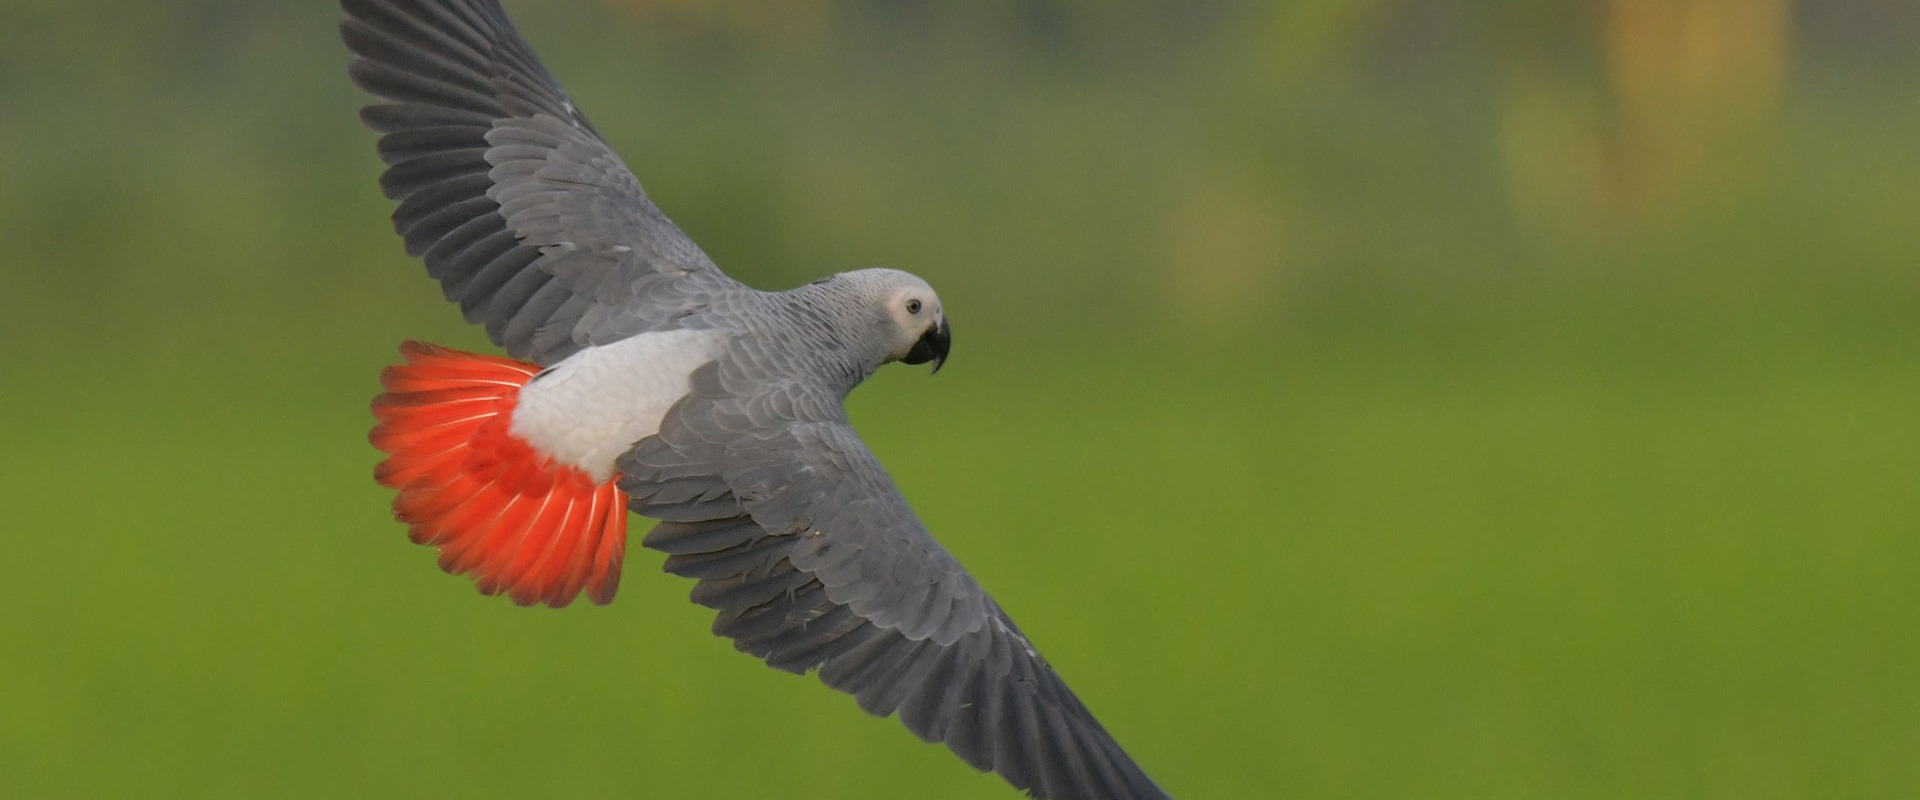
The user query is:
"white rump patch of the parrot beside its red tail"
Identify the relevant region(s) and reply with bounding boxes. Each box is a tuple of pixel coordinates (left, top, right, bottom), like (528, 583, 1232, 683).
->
(509, 330, 726, 483)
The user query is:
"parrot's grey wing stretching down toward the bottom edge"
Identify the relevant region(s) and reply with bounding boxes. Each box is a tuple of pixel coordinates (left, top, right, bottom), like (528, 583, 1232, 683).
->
(618, 361, 1165, 800)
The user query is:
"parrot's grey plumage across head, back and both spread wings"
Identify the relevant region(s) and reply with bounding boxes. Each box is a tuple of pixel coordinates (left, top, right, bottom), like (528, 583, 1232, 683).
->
(342, 0, 1165, 800)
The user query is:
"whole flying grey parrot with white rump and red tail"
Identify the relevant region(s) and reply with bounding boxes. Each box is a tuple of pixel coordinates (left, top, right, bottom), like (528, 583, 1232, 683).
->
(342, 0, 1165, 800)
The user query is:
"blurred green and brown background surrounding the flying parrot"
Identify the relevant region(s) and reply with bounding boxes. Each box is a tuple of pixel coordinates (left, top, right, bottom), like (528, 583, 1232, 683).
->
(0, 0, 1920, 800)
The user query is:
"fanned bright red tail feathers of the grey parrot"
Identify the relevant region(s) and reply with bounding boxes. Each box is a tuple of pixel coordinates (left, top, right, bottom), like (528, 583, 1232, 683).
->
(369, 341, 626, 608)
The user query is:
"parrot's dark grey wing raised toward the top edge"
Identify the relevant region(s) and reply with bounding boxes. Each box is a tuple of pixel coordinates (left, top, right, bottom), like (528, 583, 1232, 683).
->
(340, 0, 739, 363)
